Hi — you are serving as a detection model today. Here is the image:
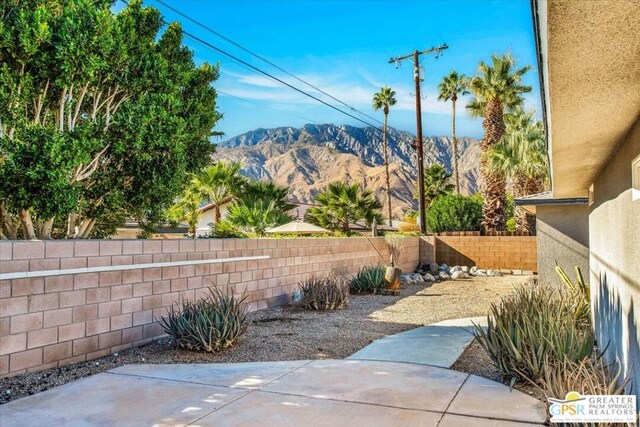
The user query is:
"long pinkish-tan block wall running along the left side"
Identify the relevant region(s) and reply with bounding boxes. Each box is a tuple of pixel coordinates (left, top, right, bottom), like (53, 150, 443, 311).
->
(0, 237, 420, 377)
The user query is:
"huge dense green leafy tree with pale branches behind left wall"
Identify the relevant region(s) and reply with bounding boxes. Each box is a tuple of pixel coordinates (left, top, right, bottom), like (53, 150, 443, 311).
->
(0, 0, 220, 239)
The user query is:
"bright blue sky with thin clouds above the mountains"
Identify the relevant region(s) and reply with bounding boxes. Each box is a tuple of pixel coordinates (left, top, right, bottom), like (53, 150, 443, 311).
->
(121, 0, 540, 137)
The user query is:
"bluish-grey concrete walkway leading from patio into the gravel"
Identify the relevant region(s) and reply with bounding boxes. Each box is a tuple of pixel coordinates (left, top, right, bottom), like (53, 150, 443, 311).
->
(348, 316, 487, 368)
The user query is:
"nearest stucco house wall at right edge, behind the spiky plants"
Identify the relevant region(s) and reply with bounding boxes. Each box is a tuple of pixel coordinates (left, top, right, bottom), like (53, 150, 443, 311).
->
(589, 117, 640, 394)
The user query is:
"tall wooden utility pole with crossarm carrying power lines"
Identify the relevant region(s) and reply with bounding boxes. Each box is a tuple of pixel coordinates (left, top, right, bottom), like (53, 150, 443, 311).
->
(389, 44, 449, 234)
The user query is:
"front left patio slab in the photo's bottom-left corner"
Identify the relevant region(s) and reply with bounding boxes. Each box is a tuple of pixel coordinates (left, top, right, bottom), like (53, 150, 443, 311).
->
(0, 373, 248, 427)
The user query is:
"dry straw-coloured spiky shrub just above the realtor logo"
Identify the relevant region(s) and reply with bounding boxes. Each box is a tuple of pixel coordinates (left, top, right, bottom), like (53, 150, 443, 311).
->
(540, 357, 630, 427)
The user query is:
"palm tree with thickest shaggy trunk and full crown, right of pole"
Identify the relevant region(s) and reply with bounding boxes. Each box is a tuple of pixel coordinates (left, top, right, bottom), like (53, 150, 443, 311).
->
(467, 53, 531, 231)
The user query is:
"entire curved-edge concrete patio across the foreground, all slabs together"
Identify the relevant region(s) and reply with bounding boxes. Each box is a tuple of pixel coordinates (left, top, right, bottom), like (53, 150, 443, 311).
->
(0, 360, 545, 427)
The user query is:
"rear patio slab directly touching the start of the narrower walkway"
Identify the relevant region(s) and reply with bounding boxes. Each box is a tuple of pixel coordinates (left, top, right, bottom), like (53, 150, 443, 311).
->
(264, 360, 468, 412)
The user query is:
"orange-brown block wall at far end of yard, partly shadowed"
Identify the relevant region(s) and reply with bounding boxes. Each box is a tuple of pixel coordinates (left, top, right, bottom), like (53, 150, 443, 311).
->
(428, 236, 537, 271)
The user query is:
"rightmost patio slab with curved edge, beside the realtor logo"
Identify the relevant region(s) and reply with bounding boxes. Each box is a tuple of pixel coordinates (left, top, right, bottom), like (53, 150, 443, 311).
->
(447, 375, 546, 422)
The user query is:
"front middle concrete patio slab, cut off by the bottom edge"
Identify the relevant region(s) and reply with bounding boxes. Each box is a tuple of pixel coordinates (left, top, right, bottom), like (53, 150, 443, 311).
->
(196, 391, 441, 427)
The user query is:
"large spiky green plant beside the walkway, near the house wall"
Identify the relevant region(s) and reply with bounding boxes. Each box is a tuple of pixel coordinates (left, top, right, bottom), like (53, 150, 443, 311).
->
(474, 285, 593, 382)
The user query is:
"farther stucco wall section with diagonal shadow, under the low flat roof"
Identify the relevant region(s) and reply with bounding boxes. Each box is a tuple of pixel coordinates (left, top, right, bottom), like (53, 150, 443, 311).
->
(536, 204, 589, 283)
